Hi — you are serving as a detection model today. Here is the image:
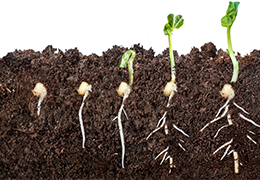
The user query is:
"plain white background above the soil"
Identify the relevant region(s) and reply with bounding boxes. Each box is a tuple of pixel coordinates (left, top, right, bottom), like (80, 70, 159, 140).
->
(0, 0, 260, 57)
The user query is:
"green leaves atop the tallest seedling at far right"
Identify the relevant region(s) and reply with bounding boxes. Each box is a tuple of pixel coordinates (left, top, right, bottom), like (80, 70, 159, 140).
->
(221, 2, 240, 28)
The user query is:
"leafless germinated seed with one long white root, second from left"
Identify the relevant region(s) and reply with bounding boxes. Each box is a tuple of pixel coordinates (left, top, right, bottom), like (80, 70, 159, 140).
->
(77, 81, 91, 148)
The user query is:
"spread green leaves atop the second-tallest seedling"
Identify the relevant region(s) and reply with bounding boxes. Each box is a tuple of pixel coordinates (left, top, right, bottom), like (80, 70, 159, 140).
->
(163, 14, 184, 35)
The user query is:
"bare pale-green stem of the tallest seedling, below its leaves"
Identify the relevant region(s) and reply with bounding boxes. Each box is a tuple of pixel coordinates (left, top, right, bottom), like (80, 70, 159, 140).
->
(227, 27, 239, 83)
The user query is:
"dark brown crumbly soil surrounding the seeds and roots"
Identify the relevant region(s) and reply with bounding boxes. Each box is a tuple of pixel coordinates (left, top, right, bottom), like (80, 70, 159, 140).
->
(0, 43, 260, 180)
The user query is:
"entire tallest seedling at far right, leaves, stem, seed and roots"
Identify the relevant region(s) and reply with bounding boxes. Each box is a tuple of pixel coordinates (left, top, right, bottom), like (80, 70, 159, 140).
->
(200, 2, 260, 174)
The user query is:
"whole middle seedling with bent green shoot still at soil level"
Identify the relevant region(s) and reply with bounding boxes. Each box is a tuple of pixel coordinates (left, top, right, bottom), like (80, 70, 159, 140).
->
(112, 50, 135, 168)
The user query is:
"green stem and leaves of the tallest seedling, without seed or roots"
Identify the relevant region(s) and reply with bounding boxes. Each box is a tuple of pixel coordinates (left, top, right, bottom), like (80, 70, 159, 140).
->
(221, 2, 239, 83)
